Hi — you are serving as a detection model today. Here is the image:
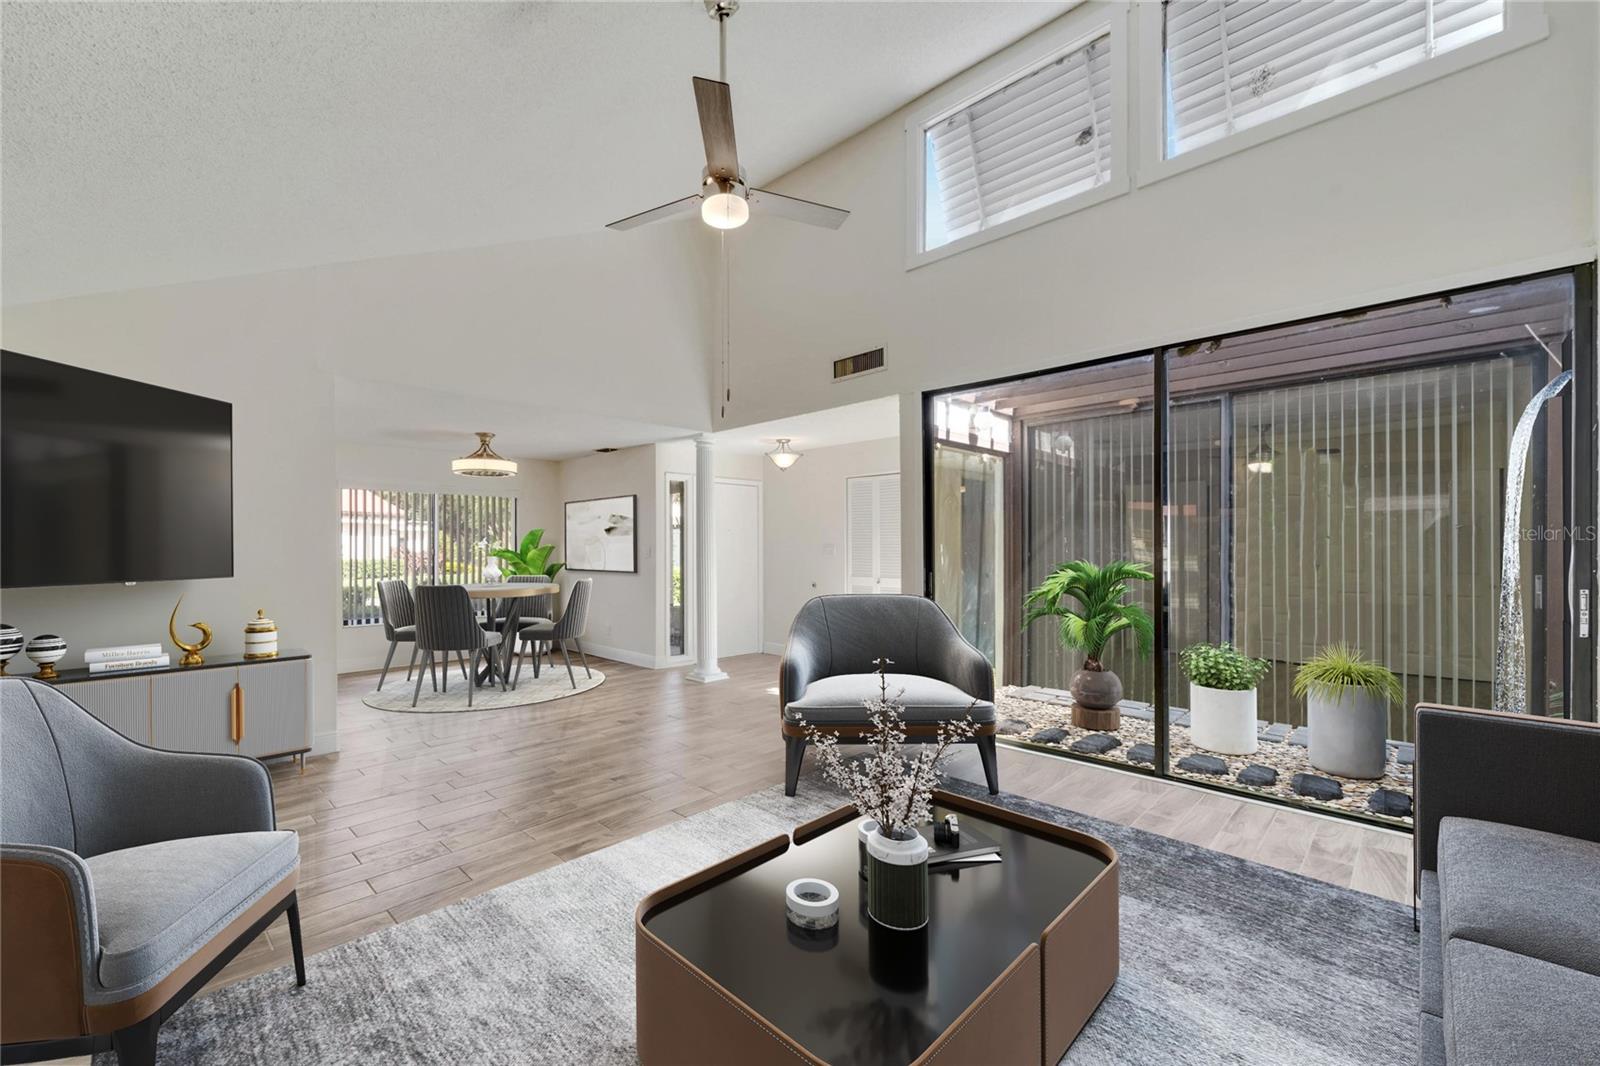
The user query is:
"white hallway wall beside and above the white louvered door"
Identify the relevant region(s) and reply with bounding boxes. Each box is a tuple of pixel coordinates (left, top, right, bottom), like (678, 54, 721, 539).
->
(762, 437, 904, 655)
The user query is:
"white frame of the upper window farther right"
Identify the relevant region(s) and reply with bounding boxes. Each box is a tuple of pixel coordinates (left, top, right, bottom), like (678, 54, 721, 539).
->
(1136, 0, 1550, 189)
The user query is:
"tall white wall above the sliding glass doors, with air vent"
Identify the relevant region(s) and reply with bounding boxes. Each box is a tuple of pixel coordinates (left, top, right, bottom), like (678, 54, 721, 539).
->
(722, 3, 1600, 589)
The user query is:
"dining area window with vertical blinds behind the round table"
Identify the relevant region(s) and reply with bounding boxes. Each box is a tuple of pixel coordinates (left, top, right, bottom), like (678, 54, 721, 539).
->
(339, 488, 517, 626)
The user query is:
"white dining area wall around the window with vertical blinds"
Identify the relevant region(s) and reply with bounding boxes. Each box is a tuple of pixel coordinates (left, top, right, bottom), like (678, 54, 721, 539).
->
(330, 442, 563, 674)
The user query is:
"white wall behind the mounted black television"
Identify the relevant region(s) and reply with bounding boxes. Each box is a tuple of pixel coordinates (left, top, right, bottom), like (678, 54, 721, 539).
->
(0, 275, 339, 752)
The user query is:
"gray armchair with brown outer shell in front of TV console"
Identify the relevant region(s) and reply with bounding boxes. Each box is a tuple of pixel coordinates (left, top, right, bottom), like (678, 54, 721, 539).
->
(0, 677, 306, 1066)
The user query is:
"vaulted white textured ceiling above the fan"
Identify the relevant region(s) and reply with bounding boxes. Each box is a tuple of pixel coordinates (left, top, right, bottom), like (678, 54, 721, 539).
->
(9, 0, 1069, 304)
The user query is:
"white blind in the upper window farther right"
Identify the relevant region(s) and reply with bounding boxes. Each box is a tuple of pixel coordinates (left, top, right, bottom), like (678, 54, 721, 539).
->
(1165, 0, 1506, 158)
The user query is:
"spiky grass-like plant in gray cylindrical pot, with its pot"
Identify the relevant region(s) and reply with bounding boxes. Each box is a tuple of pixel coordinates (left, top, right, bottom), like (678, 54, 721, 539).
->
(1294, 643, 1405, 779)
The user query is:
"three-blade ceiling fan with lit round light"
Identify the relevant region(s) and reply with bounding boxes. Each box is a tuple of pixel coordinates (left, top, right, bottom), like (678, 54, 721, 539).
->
(606, 0, 850, 229)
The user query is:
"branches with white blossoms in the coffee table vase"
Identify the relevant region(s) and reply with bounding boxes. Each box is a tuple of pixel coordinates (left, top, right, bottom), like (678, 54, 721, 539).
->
(800, 658, 978, 839)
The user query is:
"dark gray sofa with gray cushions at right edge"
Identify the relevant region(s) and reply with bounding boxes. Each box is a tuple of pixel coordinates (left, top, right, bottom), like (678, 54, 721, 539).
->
(1413, 704, 1600, 1066)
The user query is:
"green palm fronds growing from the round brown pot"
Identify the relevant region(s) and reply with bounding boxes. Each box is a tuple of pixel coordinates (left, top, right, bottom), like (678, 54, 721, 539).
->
(1022, 559, 1155, 671)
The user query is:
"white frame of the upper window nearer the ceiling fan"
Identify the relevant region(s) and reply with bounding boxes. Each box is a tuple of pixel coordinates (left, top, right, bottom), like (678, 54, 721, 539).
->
(904, 5, 1133, 271)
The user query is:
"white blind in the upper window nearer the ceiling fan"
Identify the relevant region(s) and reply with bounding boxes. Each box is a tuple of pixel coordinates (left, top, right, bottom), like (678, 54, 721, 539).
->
(923, 34, 1112, 248)
